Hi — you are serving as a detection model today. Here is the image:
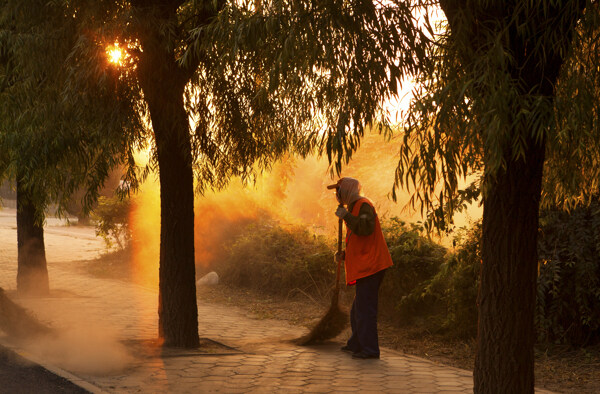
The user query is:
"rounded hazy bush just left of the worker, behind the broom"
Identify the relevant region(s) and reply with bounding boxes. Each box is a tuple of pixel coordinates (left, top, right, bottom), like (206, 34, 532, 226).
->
(217, 221, 343, 300)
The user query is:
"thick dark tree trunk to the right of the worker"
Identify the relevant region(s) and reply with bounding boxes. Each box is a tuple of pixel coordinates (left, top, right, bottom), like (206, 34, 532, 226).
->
(474, 141, 545, 393)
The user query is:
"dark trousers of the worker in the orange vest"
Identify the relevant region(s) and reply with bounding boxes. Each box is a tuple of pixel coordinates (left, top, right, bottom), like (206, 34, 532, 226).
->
(348, 270, 385, 356)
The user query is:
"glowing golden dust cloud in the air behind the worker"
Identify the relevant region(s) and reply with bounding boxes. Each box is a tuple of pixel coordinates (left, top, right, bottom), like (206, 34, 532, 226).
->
(130, 133, 480, 287)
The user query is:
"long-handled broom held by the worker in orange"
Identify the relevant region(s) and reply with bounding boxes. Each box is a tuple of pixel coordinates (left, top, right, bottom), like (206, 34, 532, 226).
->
(296, 206, 348, 346)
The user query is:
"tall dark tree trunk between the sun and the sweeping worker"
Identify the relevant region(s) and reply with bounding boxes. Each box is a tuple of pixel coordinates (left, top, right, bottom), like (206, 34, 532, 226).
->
(138, 9, 199, 348)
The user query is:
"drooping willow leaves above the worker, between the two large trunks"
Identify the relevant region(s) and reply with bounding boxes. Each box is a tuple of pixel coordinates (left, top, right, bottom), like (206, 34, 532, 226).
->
(188, 0, 426, 180)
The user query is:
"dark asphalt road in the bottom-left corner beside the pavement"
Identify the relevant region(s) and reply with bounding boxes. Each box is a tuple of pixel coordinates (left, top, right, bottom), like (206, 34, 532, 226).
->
(0, 346, 88, 394)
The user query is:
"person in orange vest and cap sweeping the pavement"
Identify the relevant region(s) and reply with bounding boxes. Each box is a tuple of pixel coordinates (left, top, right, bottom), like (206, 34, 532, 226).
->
(327, 177, 392, 359)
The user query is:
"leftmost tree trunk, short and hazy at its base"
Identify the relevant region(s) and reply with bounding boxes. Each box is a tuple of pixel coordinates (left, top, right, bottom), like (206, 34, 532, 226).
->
(17, 180, 49, 296)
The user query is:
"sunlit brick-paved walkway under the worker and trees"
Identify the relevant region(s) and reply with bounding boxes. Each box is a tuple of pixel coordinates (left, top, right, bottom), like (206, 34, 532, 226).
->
(0, 214, 547, 393)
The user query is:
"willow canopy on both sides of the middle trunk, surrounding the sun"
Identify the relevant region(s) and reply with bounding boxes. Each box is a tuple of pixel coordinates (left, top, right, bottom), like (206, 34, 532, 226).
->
(64, 0, 426, 192)
